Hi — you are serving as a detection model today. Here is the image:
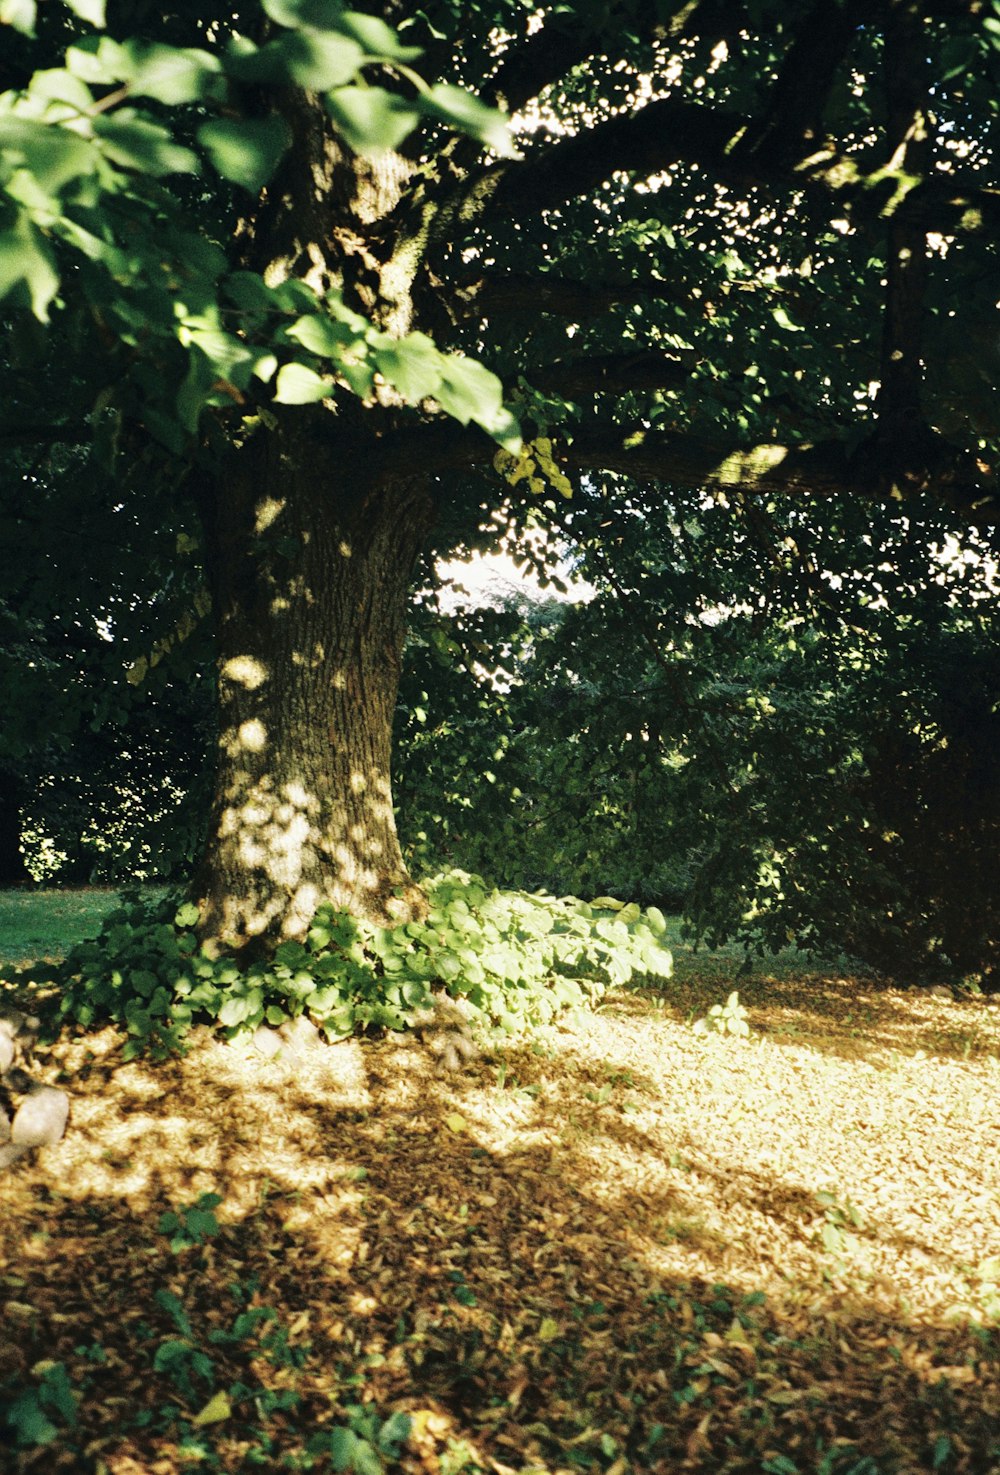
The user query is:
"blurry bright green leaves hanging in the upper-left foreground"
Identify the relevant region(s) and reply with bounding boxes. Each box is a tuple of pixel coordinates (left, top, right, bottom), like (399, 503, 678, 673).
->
(0, 0, 518, 453)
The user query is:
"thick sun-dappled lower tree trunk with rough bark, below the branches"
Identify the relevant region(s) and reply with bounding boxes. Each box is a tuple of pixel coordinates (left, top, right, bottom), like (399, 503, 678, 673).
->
(196, 410, 432, 950)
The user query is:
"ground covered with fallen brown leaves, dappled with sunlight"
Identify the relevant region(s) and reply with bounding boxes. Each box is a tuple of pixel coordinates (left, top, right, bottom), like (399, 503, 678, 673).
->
(0, 971, 1000, 1475)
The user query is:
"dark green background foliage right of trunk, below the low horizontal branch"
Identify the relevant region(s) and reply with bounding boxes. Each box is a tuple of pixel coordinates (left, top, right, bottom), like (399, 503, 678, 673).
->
(400, 487, 1000, 987)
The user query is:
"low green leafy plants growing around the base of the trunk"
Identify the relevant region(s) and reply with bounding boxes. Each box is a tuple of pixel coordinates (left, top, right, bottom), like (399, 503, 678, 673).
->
(47, 872, 671, 1056)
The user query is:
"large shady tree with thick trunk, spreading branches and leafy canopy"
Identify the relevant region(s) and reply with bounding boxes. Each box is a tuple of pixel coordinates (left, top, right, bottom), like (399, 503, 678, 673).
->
(0, 0, 1000, 948)
